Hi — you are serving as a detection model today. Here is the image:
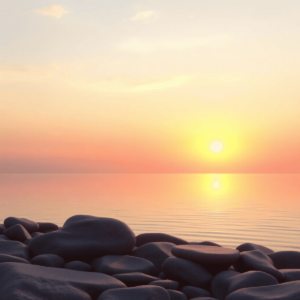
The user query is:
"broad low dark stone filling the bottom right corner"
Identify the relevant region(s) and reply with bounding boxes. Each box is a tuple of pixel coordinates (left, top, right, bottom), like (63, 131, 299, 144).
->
(226, 281, 300, 300)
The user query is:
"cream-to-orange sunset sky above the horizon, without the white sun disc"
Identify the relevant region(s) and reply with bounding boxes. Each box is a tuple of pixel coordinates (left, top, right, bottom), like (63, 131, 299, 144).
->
(0, 0, 300, 173)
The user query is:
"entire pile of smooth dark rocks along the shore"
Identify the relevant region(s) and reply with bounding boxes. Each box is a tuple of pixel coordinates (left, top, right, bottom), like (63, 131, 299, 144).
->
(0, 215, 300, 300)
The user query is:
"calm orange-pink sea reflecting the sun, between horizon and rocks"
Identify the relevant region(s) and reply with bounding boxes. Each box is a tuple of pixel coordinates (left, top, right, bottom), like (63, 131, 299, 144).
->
(0, 174, 300, 251)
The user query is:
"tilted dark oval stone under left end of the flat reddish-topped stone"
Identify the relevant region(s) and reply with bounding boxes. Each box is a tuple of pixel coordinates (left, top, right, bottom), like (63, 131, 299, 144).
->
(162, 257, 213, 287)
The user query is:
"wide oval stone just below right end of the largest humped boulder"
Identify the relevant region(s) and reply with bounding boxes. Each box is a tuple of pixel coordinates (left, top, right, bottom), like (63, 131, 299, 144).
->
(92, 255, 155, 276)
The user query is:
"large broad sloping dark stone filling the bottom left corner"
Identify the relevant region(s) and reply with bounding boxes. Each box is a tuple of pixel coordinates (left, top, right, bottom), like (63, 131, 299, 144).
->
(0, 263, 125, 300)
